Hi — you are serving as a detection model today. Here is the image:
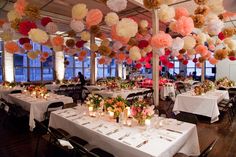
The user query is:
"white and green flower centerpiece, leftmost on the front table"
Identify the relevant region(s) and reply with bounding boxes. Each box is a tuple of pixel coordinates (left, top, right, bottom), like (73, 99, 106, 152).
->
(85, 94, 104, 111)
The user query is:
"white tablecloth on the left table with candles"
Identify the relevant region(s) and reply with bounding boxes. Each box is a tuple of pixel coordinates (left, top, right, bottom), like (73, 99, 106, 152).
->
(8, 93, 73, 130)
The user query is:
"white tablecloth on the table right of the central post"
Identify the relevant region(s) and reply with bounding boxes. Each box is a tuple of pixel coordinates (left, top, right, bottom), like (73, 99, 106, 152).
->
(173, 90, 229, 123)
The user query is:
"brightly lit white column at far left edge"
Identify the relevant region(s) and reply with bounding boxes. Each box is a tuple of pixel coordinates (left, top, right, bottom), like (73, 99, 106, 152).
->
(3, 51, 14, 82)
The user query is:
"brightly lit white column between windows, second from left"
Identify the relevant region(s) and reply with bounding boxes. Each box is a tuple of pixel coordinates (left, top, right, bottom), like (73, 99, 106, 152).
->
(55, 51, 65, 81)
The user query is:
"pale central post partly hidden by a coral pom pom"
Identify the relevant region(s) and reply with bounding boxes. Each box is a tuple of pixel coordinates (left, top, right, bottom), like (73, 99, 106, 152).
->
(152, 9, 159, 106)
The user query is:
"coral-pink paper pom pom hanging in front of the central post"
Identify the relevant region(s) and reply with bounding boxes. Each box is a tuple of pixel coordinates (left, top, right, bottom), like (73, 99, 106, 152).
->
(151, 31, 173, 48)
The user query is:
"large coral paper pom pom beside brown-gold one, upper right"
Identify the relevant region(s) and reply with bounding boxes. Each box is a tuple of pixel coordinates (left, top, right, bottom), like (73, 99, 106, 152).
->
(171, 16, 194, 36)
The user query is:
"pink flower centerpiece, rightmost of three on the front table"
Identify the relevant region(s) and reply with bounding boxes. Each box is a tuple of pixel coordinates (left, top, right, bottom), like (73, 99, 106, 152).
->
(131, 99, 154, 125)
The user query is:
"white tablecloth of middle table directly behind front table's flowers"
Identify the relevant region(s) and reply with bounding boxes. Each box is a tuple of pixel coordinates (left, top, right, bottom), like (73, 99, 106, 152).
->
(92, 88, 150, 99)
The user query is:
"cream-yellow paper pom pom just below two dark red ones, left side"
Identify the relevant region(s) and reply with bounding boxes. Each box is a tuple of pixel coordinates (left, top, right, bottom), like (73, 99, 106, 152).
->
(28, 28, 49, 43)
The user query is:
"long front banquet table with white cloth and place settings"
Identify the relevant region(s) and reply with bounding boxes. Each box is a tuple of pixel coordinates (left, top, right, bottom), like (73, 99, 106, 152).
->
(49, 107, 200, 157)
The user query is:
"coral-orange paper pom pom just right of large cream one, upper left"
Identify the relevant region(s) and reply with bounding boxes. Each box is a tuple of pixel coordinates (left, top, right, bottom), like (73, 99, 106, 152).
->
(86, 9, 103, 28)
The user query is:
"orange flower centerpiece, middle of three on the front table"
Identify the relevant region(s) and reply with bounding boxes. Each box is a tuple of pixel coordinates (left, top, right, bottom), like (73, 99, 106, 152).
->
(104, 96, 128, 118)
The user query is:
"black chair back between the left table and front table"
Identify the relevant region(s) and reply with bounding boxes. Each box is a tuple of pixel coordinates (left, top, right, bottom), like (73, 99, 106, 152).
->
(43, 102, 64, 126)
